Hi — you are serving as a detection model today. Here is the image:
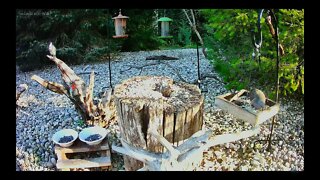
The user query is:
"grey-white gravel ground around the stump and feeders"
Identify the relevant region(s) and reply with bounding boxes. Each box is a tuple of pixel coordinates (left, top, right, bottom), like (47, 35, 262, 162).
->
(16, 49, 304, 171)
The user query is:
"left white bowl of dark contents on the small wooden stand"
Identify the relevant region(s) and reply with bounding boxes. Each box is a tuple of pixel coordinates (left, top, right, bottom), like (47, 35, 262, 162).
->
(52, 129, 78, 147)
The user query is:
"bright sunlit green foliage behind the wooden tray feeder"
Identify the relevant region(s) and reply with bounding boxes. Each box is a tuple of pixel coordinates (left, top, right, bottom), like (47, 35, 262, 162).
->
(201, 9, 304, 97)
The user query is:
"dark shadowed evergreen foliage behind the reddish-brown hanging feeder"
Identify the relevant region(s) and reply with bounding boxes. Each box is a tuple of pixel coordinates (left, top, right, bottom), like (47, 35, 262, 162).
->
(16, 9, 160, 71)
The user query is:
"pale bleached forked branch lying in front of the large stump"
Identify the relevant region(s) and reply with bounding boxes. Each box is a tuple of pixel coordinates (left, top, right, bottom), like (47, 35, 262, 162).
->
(112, 123, 260, 171)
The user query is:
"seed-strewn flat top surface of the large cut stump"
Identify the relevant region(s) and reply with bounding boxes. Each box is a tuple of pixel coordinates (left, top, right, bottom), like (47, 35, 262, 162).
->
(114, 76, 202, 112)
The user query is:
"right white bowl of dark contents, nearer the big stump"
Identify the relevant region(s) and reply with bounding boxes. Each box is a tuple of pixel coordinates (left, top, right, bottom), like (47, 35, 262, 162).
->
(79, 126, 108, 146)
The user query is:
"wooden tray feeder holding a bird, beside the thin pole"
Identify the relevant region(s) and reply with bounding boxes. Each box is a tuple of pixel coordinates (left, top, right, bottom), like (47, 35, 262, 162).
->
(215, 89, 280, 126)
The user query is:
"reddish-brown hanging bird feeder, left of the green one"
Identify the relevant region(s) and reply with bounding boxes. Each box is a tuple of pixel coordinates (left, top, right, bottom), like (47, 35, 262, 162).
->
(112, 9, 129, 38)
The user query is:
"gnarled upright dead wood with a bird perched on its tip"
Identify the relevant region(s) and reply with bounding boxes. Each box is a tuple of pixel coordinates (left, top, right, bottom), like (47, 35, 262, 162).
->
(31, 43, 116, 127)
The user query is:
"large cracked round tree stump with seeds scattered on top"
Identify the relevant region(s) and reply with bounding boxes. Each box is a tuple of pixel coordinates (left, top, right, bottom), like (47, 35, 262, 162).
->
(114, 76, 204, 171)
